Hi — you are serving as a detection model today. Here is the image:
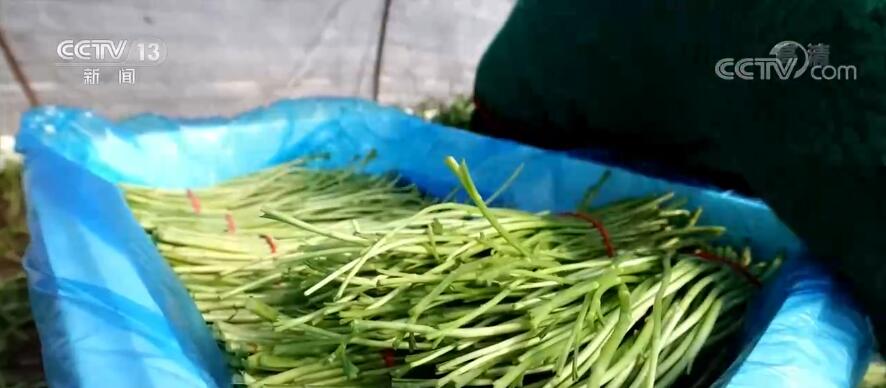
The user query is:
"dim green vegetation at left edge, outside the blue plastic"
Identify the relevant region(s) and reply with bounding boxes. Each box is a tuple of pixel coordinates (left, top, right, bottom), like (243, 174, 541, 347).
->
(0, 161, 45, 387)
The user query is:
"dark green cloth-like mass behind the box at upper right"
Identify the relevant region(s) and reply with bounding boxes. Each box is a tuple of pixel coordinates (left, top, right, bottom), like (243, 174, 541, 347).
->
(472, 0, 886, 341)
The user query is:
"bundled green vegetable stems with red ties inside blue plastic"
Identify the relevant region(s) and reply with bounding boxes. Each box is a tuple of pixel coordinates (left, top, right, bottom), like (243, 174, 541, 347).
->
(125, 152, 779, 387)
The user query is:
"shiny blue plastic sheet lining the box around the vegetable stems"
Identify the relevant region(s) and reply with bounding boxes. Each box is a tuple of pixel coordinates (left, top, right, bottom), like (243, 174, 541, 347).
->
(17, 99, 873, 388)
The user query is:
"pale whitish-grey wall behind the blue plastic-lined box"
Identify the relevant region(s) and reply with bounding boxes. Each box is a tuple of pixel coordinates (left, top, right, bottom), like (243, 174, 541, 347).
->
(0, 0, 514, 133)
